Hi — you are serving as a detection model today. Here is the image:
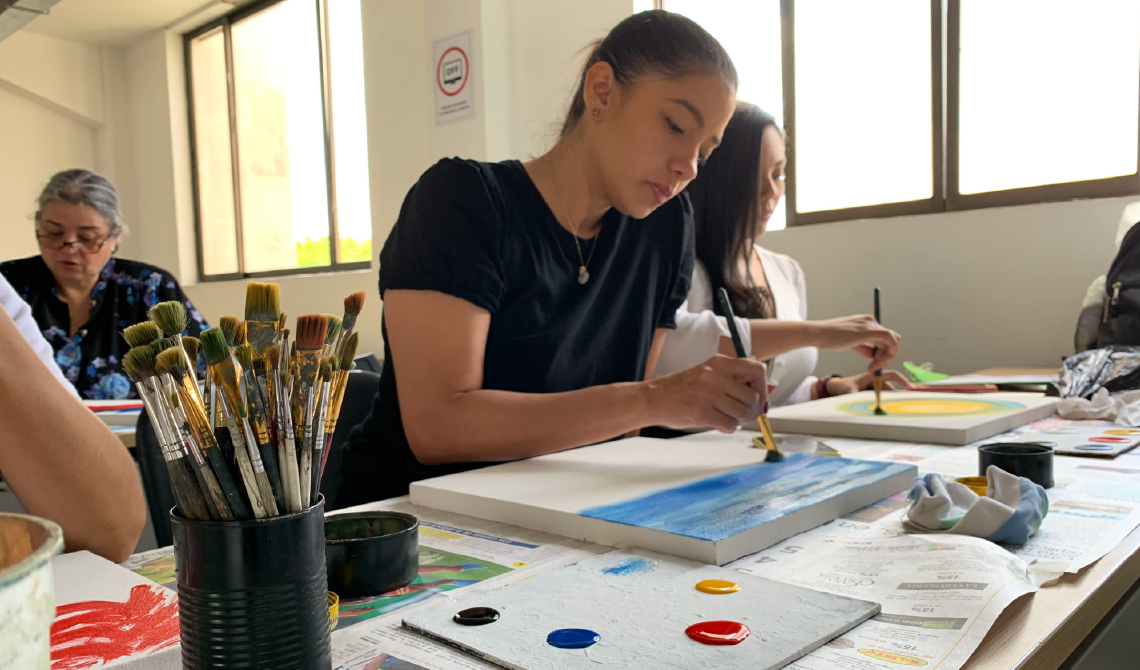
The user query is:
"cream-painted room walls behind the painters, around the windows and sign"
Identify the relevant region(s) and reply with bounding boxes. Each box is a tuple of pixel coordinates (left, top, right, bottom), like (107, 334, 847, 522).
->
(13, 0, 1131, 373)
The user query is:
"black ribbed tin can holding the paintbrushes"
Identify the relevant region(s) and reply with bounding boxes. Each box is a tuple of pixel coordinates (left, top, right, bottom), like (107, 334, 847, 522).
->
(170, 498, 333, 670)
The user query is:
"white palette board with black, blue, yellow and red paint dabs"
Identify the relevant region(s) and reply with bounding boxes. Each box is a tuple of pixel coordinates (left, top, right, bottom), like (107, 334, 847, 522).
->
(404, 551, 880, 670)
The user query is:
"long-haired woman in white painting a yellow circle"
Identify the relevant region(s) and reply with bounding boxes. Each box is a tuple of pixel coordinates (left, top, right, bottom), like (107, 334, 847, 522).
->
(654, 103, 906, 406)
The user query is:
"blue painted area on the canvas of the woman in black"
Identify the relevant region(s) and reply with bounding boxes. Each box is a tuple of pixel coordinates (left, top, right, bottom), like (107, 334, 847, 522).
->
(578, 454, 918, 541)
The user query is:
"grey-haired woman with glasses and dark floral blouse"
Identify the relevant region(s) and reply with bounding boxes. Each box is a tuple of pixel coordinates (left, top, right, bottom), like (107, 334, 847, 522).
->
(0, 169, 207, 400)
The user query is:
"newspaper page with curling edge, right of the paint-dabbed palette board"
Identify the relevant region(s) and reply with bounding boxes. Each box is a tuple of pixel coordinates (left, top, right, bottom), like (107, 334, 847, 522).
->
(730, 529, 1037, 670)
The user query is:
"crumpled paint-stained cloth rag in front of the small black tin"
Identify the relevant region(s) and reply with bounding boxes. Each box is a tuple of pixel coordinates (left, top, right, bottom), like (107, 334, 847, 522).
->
(903, 465, 1049, 545)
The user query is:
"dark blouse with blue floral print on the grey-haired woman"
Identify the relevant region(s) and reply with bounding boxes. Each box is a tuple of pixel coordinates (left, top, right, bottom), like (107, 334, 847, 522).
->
(0, 256, 209, 400)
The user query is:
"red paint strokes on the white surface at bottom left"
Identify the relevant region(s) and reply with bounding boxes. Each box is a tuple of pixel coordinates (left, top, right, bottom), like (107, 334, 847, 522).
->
(51, 585, 179, 670)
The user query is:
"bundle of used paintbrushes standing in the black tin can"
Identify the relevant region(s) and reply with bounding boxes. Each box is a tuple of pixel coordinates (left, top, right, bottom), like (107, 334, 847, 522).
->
(116, 281, 365, 521)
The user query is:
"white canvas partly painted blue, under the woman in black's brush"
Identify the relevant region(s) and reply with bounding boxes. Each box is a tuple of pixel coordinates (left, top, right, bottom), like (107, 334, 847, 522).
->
(410, 438, 918, 565)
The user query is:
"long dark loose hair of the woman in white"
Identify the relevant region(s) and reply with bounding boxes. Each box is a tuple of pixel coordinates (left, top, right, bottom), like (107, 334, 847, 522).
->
(685, 103, 779, 319)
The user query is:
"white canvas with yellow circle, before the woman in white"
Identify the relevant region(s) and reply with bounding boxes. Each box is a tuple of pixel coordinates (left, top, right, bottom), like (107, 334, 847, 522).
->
(768, 391, 1058, 447)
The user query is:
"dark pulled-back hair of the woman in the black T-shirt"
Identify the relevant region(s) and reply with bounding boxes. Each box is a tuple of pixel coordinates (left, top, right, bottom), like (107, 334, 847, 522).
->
(562, 9, 736, 137)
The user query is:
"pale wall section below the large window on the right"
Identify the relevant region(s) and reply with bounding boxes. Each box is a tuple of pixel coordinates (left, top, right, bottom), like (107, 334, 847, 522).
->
(763, 197, 1137, 374)
